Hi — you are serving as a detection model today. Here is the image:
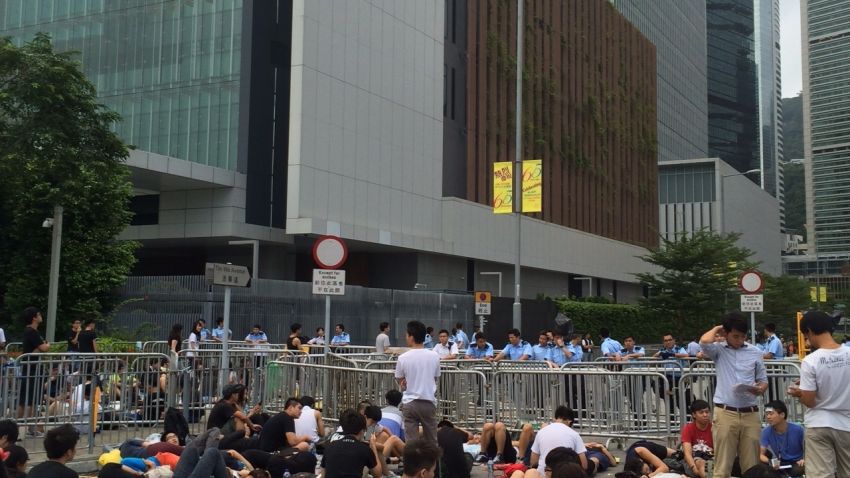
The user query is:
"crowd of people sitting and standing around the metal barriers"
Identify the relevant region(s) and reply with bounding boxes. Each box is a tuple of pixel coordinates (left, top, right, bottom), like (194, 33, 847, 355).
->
(0, 309, 850, 478)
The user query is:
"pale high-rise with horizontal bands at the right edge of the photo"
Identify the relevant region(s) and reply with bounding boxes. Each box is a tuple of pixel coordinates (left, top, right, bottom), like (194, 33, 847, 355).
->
(800, 0, 850, 261)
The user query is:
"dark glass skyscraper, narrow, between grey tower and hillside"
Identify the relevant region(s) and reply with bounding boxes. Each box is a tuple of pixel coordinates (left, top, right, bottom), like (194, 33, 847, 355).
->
(705, 0, 761, 177)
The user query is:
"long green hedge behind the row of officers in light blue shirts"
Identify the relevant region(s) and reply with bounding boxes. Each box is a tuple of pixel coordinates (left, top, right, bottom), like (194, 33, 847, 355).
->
(555, 298, 680, 343)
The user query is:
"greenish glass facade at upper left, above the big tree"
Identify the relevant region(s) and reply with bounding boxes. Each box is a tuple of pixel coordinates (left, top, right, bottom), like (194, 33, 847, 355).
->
(0, 0, 243, 170)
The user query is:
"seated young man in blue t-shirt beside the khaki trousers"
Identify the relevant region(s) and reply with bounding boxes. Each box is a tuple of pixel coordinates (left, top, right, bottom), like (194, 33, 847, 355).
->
(759, 400, 805, 476)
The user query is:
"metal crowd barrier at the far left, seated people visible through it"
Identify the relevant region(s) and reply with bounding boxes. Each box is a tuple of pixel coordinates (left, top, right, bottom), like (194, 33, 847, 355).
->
(0, 353, 174, 454)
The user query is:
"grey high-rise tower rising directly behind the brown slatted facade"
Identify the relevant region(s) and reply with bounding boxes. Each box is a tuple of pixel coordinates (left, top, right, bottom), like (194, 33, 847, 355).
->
(611, 0, 708, 162)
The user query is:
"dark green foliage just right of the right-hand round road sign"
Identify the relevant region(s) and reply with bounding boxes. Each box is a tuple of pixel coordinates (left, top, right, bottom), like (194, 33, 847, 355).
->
(756, 274, 811, 335)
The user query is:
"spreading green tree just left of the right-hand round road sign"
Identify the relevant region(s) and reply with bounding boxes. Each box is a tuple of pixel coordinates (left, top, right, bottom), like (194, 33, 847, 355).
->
(635, 230, 757, 337)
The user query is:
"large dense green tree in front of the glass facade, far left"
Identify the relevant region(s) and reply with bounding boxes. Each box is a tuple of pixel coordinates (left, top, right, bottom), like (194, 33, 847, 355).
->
(0, 34, 137, 334)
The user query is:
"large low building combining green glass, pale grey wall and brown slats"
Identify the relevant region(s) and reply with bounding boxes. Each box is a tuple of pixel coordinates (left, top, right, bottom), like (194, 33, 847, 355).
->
(0, 0, 660, 301)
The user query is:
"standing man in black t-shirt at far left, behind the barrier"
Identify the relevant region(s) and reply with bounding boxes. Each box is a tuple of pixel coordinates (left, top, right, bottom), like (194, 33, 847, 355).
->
(18, 307, 50, 424)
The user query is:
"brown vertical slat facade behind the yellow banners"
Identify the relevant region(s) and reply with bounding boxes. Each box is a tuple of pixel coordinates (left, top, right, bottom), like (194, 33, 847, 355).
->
(466, 0, 658, 246)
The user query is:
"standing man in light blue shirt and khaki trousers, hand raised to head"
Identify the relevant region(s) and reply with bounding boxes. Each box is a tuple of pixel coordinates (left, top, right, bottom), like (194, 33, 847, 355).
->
(700, 312, 767, 478)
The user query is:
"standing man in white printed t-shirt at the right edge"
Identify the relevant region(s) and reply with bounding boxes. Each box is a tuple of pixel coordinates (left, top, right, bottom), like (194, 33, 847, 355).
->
(788, 310, 850, 476)
